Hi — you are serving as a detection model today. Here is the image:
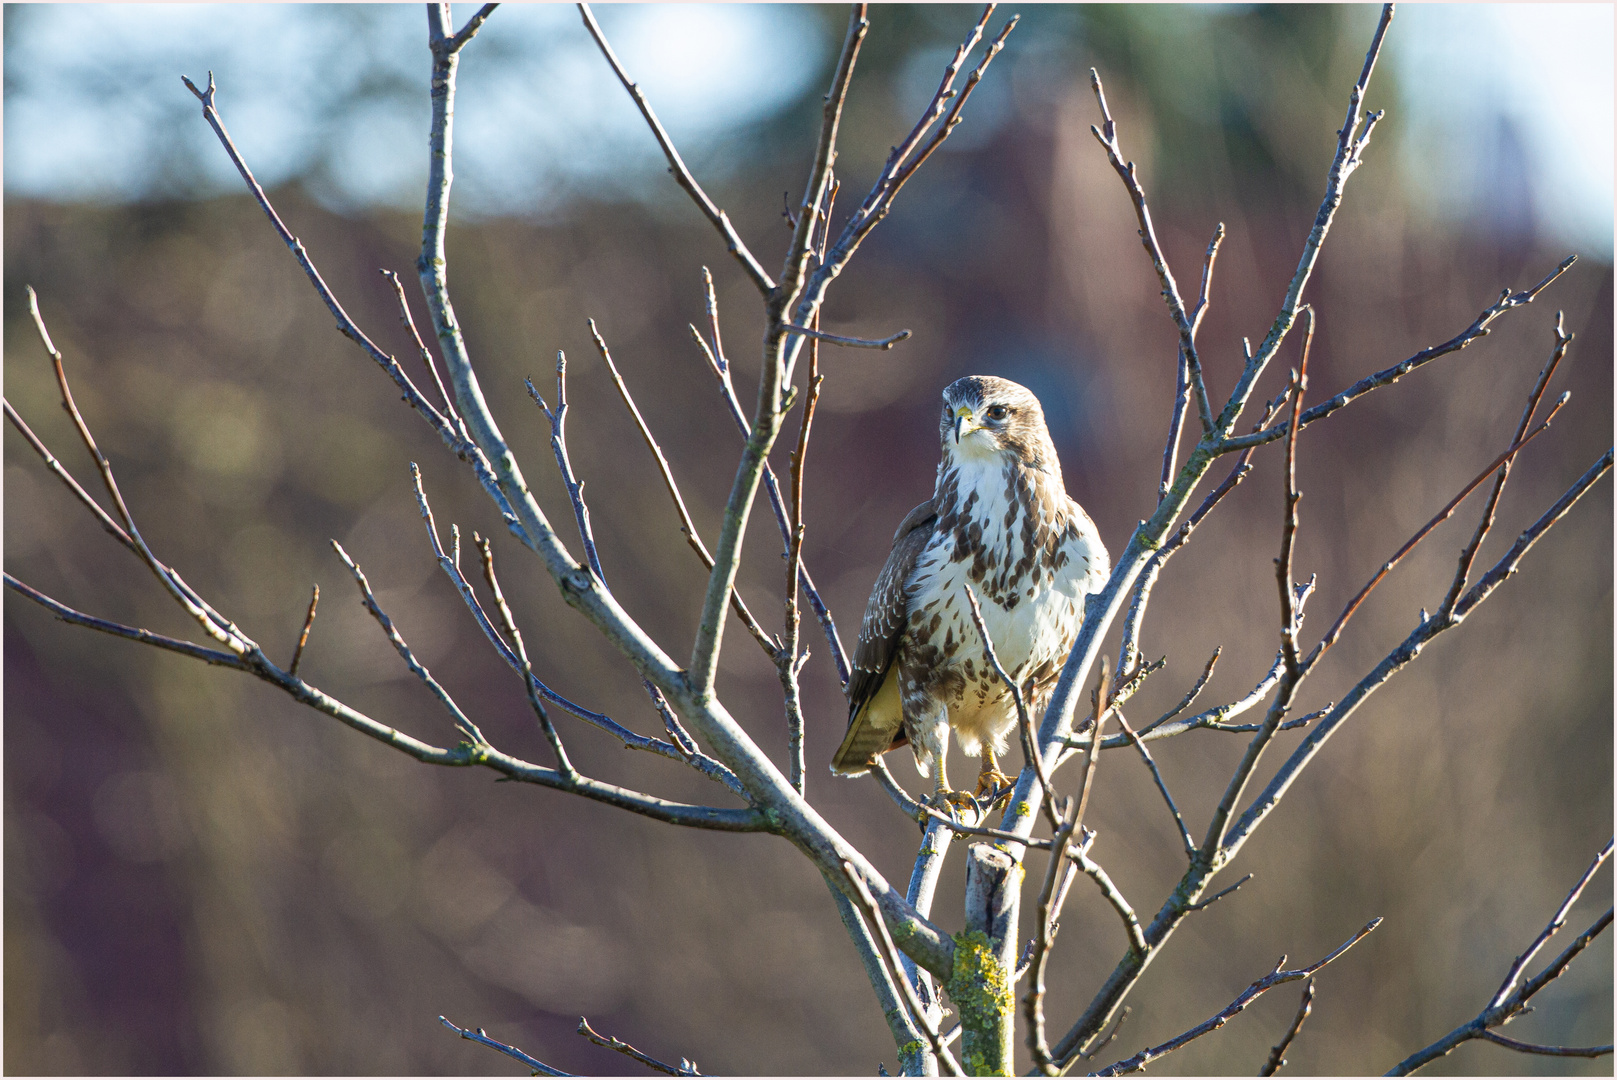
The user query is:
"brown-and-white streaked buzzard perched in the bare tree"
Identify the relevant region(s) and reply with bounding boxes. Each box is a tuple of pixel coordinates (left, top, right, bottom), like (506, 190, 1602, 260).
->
(831, 375, 1111, 805)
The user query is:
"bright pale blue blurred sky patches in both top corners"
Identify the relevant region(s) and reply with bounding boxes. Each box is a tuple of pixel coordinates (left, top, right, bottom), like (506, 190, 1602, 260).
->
(5, 3, 1614, 259)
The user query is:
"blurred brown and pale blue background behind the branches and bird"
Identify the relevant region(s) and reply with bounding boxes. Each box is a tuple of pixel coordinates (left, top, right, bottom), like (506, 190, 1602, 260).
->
(3, 5, 1612, 1075)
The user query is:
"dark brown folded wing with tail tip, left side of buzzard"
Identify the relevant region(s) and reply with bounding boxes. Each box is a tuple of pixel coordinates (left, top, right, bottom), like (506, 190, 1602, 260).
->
(831, 500, 938, 776)
